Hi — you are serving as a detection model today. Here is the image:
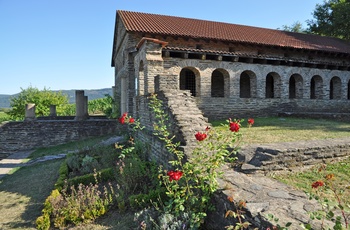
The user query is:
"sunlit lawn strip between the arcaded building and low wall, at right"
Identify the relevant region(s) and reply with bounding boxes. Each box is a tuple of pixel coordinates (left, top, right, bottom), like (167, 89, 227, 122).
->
(212, 117, 350, 144)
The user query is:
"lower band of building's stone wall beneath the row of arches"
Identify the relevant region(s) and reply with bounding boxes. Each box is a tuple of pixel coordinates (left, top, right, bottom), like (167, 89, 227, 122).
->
(196, 97, 350, 121)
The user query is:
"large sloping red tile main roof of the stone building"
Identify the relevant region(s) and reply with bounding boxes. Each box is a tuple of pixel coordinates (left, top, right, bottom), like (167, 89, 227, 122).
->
(117, 10, 350, 53)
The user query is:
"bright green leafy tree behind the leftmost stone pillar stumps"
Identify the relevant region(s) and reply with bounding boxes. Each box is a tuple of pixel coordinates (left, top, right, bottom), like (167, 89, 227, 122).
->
(8, 86, 68, 120)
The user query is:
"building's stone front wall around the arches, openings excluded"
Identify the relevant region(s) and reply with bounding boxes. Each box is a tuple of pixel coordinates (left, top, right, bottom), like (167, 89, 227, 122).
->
(159, 58, 350, 120)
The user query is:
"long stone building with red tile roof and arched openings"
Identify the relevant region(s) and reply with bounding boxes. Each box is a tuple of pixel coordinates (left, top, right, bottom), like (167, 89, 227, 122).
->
(112, 10, 350, 119)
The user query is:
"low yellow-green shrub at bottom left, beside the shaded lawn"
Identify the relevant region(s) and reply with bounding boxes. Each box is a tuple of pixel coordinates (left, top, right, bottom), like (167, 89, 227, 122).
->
(36, 177, 117, 229)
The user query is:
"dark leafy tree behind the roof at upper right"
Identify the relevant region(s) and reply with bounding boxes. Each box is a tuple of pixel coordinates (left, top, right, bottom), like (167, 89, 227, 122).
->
(307, 0, 350, 41)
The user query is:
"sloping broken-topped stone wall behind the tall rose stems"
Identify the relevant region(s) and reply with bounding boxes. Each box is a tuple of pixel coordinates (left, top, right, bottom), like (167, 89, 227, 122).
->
(135, 90, 209, 166)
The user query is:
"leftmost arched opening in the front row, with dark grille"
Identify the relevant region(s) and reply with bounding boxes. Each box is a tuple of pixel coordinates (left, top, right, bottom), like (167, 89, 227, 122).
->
(180, 67, 200, 97)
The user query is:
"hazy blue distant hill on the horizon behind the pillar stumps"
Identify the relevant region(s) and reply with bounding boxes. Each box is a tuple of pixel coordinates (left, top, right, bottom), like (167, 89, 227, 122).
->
(0, 88, 112, 108)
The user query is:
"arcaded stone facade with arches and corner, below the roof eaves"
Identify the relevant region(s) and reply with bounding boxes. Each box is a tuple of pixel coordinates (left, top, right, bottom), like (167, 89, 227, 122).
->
(128, 43, 350, 120)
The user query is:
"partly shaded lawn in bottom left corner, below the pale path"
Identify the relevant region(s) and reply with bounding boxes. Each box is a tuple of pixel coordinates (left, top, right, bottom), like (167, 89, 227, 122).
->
(0, 160, 62, 229)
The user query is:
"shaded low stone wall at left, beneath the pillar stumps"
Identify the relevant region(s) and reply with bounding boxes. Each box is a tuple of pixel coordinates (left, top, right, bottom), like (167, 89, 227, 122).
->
(0, 119, 126, 158)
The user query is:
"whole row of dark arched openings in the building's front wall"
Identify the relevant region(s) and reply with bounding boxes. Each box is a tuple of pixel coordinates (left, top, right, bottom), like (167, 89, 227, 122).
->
(179, 68, 350, 100)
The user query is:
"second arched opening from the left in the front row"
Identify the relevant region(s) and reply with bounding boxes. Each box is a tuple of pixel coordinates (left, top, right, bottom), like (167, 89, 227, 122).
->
(211, 69, 230, 97)
